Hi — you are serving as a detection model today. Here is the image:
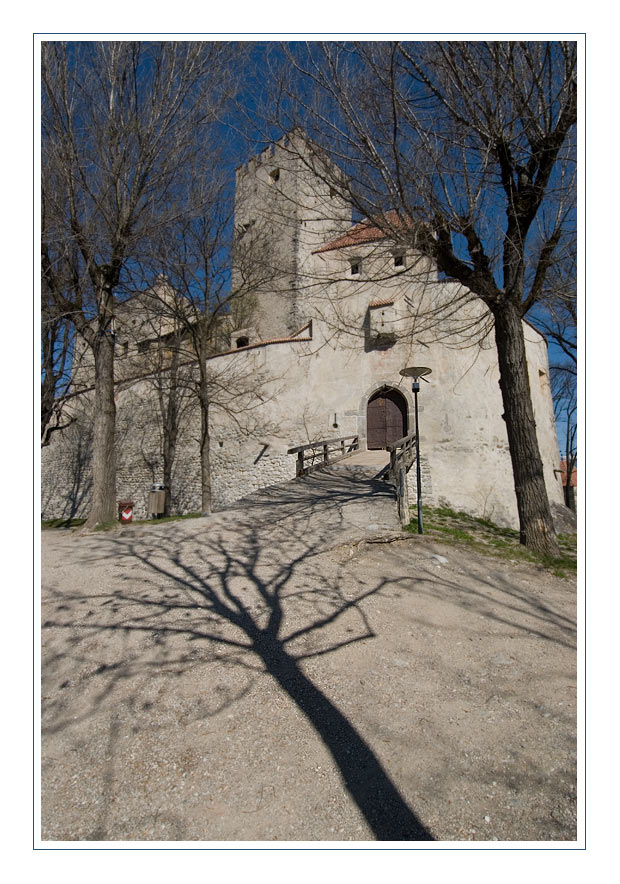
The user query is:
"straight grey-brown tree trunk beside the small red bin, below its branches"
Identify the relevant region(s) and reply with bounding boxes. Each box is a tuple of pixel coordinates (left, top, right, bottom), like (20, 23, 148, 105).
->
(84, 334, 116, 530)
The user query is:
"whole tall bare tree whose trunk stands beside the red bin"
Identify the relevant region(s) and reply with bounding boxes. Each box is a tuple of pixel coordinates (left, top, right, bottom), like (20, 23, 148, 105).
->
(41, 42, 245, 527)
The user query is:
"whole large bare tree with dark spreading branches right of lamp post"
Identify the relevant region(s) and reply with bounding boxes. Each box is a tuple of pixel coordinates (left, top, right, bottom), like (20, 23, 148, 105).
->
(266, 41, 577, 555)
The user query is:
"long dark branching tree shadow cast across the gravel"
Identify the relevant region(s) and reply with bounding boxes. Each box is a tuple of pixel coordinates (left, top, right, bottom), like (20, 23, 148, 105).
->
(44, 476, 434, 841)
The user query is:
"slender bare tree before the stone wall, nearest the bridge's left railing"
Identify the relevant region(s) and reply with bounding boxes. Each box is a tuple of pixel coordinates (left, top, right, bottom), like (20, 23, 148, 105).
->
(142, 162, 275, 515)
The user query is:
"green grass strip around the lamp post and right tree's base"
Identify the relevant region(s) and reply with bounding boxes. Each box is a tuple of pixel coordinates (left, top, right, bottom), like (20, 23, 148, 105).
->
(404, 506, 577, 577)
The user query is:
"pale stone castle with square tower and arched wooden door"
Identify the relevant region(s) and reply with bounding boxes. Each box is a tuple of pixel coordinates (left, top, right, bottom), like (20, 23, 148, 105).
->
(42, 134, 563, 526)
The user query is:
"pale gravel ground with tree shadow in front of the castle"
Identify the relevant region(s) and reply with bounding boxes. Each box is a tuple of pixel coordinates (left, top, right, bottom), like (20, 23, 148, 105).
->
(41, 476, 577, 842)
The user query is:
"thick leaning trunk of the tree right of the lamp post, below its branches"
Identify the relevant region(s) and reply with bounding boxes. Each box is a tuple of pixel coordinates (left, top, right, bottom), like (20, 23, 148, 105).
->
(493, 300, 560, 556)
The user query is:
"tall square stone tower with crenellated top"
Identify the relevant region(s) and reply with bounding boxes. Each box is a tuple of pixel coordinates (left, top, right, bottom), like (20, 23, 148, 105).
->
(232, 132, 351, 343)
